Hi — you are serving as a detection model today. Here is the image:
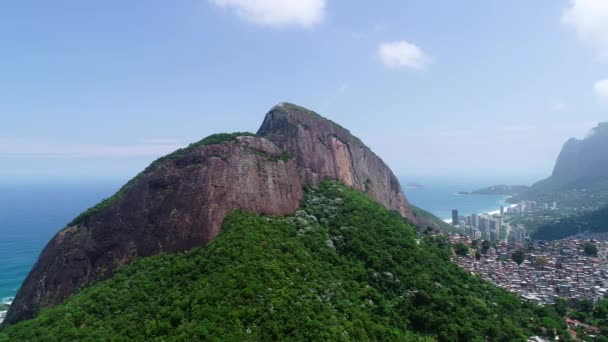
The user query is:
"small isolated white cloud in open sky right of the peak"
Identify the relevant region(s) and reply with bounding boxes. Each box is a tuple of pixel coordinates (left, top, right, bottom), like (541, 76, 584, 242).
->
(378, 40, 430, 69)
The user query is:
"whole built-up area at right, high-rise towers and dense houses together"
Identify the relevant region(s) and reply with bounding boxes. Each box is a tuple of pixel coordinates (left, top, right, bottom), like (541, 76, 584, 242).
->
(445, 192, 608, 340)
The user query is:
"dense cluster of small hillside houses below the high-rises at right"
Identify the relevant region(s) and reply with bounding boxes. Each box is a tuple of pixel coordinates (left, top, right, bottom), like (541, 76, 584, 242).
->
(449, 235, 608, 305)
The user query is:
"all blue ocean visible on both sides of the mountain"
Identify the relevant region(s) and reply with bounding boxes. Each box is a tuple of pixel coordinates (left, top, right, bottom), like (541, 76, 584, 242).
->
(0, 182, 504, 303)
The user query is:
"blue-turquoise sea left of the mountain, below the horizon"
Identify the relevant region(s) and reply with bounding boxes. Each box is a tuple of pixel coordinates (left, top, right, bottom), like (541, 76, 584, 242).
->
(0, 184, 118, 303)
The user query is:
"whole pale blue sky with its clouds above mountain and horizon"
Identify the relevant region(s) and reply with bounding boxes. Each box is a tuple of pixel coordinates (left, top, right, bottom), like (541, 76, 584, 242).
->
(0, 0, 608, 183)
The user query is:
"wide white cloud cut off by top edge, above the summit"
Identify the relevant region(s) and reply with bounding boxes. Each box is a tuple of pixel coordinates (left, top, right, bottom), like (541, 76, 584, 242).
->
(209, 0, 326, 28)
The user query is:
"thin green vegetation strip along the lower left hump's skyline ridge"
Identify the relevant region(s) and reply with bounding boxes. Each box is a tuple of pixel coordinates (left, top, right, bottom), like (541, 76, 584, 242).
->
(66, 132, 256, 228)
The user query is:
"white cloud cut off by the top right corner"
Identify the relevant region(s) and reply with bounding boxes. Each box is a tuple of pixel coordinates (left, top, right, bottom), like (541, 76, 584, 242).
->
(562, 0, 608, 60)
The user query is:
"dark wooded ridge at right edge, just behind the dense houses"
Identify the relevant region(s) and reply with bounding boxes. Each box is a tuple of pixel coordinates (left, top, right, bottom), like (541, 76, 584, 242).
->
(532, 207, 608, 240)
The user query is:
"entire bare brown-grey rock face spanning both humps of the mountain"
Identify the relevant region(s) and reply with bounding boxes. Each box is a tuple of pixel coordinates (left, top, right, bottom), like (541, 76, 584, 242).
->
(4, 104, 416, 324)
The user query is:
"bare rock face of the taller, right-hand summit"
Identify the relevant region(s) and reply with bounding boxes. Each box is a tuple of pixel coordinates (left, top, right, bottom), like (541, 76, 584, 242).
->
(258, 103, 416, 222)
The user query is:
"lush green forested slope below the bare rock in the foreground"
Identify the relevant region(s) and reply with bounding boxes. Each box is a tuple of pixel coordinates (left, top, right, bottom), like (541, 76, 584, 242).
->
(0, 181, 562, 341)
